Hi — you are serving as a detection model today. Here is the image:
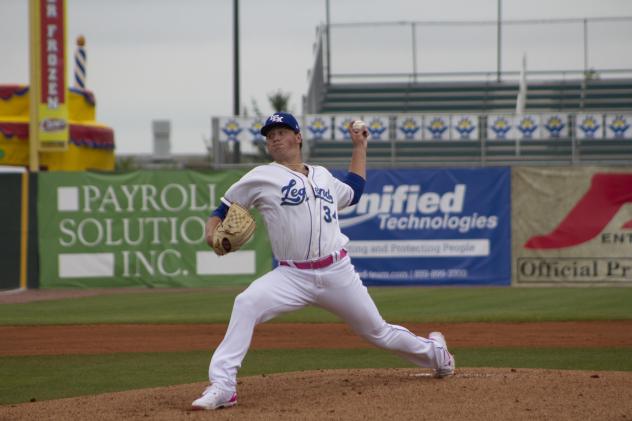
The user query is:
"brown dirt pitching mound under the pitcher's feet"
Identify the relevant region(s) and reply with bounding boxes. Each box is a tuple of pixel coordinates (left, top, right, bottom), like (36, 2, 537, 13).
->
(0, 368, 632, 421)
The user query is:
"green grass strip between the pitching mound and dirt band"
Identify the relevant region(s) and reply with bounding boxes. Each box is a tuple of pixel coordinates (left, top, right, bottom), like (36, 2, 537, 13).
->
(0, 348, 632, 405)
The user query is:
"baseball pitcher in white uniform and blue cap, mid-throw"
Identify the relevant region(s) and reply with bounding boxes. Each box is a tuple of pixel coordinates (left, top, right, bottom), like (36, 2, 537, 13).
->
(192, 112, 455, 409)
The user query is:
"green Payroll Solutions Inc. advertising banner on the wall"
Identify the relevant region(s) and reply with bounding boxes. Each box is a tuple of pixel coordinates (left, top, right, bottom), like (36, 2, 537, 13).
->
(38, 171, 272, 288)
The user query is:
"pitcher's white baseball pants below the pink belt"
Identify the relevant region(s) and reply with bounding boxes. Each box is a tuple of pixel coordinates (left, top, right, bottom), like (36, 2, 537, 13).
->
(209, 257, 435, 391)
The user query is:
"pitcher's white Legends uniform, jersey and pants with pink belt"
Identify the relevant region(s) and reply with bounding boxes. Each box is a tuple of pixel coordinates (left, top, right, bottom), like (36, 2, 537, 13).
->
(209, 163, 435, 391)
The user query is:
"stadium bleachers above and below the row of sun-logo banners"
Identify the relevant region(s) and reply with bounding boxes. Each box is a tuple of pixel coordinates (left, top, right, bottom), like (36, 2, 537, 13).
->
(309, 79, 632, 167)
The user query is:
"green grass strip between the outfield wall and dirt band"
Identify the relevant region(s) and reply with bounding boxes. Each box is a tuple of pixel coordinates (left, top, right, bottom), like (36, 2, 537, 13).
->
(0, 286, 632, 325)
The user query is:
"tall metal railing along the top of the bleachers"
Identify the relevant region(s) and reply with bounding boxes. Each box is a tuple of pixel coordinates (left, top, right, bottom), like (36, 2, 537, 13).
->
(303, 16, 632, 113)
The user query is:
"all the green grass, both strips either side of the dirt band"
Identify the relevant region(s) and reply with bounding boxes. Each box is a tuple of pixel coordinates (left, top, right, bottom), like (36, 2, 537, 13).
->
(0, 287, 632, 404)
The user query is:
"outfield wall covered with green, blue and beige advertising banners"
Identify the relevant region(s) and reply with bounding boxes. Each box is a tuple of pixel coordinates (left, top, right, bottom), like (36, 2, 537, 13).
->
(0, 167, 632, 289)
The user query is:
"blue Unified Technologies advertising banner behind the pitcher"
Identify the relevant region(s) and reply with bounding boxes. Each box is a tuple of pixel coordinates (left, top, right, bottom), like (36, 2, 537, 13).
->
(335, 168, 511, 285)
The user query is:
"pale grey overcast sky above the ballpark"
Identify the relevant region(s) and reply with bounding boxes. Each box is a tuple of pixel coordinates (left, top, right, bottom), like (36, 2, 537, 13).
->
(0, 0, 632, 154)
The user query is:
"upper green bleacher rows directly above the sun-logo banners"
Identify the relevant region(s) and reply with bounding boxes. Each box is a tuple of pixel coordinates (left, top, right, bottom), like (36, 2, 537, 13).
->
(318, 79, 632, 113)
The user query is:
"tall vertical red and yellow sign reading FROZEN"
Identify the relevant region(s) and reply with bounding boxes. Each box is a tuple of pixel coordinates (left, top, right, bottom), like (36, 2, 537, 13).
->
(30, 0, 69, 151)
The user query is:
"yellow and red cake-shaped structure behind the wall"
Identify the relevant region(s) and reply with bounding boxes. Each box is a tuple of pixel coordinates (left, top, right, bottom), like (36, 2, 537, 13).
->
(0, 85, 115, 171)
